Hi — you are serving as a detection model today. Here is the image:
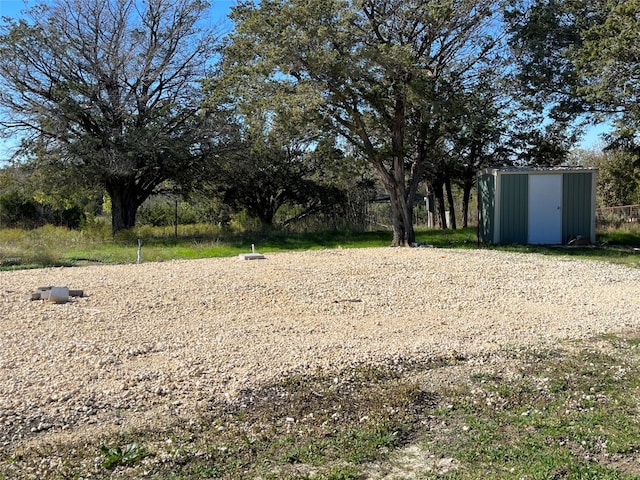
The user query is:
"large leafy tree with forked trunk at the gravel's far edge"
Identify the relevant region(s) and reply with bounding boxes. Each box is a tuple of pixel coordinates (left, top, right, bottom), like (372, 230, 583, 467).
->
(225, 0, 508, 245)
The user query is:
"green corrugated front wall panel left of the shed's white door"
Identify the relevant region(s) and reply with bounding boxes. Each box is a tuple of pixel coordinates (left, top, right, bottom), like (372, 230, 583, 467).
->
(500, 174, 529, 244)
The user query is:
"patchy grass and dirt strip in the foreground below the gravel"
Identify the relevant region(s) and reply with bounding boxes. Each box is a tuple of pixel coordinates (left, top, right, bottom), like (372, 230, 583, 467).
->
(0, 332, 640, 480)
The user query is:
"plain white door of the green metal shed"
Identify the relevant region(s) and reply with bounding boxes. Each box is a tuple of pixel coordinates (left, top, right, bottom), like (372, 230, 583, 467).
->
(528, 174, 562, 245)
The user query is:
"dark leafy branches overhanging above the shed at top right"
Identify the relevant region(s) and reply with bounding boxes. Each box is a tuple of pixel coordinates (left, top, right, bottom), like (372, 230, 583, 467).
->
(508, 0, 640, 141)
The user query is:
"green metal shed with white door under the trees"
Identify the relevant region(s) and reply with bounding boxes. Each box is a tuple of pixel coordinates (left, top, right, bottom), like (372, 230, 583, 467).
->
(478, 167, 597, 245)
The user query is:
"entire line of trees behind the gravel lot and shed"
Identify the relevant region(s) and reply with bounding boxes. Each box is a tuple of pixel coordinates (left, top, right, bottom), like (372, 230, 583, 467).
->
(0, 0, 640, 245)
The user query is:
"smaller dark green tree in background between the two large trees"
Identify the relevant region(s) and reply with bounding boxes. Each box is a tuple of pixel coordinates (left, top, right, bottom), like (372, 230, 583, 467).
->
(210, 105, 345, 229)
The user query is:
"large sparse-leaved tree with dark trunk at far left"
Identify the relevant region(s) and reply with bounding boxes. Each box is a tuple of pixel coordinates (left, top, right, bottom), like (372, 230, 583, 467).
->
(0, 0, 212, 232)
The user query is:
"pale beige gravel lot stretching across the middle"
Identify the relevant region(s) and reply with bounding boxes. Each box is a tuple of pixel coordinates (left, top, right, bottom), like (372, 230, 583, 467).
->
(0, 248, 640, 449)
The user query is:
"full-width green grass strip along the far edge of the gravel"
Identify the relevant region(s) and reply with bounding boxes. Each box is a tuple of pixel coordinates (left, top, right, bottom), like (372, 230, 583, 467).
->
(0, 225, 640, 270)
